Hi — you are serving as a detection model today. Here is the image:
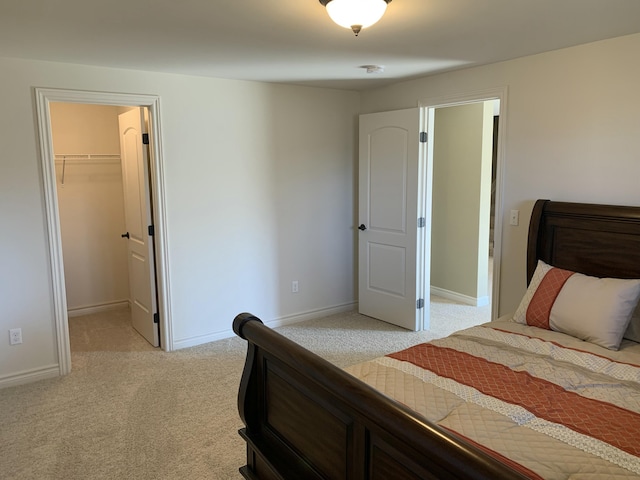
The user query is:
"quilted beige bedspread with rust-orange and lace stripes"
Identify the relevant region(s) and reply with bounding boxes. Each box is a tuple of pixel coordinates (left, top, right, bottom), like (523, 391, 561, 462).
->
(347, 321, 640, 479)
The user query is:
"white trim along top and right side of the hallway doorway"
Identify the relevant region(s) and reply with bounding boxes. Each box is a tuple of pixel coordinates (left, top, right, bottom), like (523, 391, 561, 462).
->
(418, 86, 508, 320)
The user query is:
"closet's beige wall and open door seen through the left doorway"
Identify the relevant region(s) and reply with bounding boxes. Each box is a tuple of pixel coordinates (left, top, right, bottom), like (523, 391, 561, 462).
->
(50, 102, 160, 347)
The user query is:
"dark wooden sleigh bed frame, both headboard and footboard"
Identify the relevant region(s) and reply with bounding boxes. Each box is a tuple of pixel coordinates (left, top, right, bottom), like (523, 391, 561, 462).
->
(233, 200, 640, 480)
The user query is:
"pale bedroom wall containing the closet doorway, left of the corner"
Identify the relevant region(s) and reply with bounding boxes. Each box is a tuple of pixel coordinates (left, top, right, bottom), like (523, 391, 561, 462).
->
(0, 58, 359, 384)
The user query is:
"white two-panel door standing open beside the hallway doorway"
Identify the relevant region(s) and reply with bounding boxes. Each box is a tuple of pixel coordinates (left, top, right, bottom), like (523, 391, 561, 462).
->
(358, 108, 429, 330)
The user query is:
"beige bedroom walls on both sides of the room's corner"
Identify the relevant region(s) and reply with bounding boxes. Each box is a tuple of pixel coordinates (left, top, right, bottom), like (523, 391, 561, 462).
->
(0, 31, 640, 383)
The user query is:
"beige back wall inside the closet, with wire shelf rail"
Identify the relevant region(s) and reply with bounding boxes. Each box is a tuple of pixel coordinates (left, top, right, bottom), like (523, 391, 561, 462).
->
(51, 103, 129, 313)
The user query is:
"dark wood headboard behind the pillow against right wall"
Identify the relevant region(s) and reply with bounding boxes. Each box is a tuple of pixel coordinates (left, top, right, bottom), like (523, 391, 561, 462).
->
(527, 200, 640, 284)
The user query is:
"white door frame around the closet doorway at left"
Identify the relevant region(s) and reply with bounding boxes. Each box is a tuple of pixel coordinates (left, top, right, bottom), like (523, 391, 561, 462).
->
(34, 88, 173, 375)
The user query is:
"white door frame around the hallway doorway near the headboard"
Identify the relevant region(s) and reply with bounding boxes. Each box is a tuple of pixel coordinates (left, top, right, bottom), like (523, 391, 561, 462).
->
(418, 86, 507, 318)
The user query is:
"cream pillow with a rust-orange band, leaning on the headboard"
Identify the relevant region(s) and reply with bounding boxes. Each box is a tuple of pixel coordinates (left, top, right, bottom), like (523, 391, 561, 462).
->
(513, 261, 640, 350)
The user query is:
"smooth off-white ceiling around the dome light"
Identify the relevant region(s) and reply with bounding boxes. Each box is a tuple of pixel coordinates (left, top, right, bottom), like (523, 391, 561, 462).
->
(0, 0, 640, 90)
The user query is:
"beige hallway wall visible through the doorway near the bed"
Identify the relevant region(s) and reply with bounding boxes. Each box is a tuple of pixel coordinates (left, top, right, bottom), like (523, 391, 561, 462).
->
(431, 102, 493, 304)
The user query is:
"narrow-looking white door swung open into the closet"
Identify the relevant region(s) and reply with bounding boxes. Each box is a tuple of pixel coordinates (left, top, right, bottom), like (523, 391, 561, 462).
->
(118, 108, 160, 347)
